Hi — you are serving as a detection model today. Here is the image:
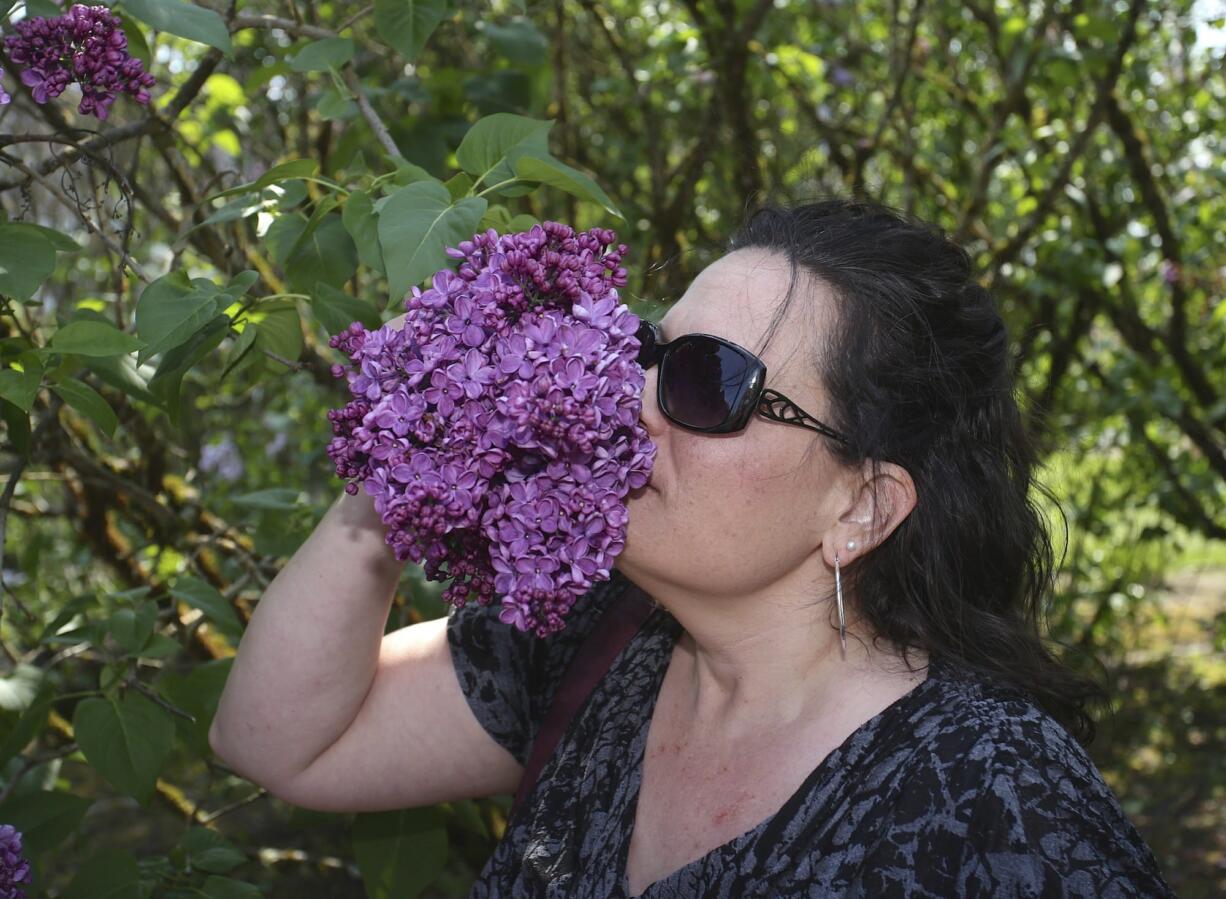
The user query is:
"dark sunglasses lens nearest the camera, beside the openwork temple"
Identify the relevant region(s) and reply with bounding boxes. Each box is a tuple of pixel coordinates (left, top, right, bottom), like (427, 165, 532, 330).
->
(660, 336, 749, 428)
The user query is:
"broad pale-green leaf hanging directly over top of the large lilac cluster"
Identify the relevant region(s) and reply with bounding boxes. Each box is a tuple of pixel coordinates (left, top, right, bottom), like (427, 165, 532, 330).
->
(379, 182, 487, 302)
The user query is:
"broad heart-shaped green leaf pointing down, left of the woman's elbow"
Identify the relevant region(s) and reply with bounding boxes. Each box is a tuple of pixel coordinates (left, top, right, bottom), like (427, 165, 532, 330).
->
(72, 691, 174, 806)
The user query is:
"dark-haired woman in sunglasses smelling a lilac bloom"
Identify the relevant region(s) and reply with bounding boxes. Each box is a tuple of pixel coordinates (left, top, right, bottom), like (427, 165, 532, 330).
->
(212, 200, 1170, 899)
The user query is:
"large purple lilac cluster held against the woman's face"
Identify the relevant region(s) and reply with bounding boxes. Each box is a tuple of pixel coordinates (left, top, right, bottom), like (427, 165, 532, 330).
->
(327, 222, 656, 637)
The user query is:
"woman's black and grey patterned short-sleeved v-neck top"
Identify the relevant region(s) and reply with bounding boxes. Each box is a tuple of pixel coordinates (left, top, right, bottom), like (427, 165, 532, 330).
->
(447, 572, 1173, 899)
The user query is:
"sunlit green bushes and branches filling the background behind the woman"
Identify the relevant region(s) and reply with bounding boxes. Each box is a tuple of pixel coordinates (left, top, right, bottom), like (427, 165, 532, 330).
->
(0, 0, 1226, 897)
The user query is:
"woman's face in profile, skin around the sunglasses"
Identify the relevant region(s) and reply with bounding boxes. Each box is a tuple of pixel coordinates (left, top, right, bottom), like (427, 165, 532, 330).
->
(617, 248, 847, 595)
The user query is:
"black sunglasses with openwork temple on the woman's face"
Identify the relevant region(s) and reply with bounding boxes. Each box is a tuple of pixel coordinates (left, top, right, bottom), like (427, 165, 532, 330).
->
(636, 321, 848, 443)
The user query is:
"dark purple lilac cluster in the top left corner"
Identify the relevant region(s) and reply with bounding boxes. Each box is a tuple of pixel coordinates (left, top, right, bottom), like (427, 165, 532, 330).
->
(4, 4, 154, 119)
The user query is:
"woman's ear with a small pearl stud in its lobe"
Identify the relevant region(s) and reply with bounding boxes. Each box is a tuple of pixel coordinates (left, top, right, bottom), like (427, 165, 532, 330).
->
(821, 460, 916, 568)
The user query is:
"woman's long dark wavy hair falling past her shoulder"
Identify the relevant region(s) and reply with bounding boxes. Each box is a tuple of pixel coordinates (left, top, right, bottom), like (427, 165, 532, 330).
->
(731, 199, 1105, 743)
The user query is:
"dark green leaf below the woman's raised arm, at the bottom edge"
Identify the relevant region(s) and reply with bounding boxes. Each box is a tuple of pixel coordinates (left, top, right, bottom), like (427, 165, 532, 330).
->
(353, 808, 447, 899)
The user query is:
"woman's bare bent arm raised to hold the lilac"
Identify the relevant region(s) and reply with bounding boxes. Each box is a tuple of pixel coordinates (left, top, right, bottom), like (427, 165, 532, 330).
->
(208, 310, 522, 811)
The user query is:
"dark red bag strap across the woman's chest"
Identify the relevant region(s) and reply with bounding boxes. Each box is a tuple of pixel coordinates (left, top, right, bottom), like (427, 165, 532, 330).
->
(511, 584, 656, 818)
